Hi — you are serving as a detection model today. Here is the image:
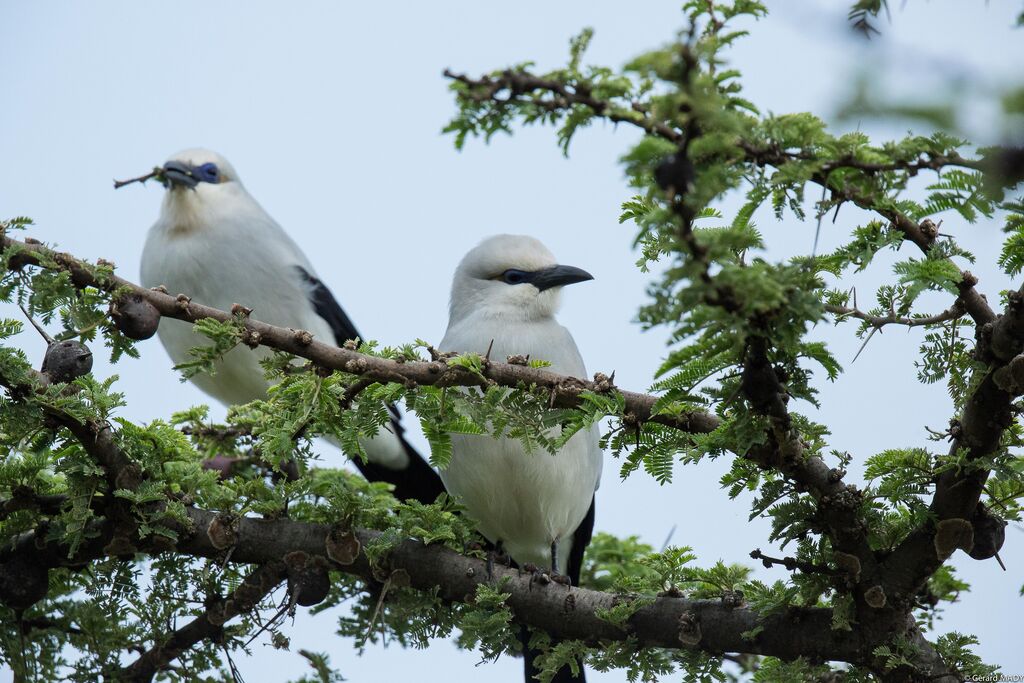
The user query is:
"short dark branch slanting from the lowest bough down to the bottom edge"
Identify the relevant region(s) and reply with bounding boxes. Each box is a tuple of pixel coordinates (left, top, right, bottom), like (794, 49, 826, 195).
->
(114, 560, 287, 683)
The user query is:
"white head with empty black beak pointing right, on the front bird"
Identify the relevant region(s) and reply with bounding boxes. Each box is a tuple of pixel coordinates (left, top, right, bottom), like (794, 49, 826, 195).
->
(451, 234, 594, 321)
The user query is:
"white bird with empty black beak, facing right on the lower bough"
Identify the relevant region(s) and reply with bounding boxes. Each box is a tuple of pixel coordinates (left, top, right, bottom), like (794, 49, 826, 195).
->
(438, 234, 602, 681)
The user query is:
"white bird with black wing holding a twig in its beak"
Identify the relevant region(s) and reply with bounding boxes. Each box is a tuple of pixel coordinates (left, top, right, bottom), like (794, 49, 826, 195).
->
(141, 148, 444, 504)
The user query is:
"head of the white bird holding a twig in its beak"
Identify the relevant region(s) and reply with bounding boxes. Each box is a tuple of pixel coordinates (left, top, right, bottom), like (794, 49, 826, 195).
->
(153, 148, 245, 230)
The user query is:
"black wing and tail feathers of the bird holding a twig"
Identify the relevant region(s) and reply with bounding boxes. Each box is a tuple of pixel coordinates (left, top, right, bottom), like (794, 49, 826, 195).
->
(296, 265, 444, 503)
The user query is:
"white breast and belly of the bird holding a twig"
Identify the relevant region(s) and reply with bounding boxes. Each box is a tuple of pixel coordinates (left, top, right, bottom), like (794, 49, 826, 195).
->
(141, 184, 409, 469)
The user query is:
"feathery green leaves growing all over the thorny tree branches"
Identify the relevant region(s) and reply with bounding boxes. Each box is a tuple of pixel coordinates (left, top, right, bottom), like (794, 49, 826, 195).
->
(0, 0, 1024, 683)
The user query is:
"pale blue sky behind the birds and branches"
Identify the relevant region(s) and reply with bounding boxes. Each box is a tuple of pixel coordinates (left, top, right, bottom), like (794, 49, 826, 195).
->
(0, 0, 1024, 683)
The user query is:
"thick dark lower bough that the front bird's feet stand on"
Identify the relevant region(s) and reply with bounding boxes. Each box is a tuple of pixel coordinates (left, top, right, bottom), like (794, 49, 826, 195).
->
(0, 508, 870, 661)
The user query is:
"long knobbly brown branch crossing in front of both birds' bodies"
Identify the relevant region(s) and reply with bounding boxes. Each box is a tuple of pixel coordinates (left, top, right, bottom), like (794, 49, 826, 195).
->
(0, 236, 719, 433)
